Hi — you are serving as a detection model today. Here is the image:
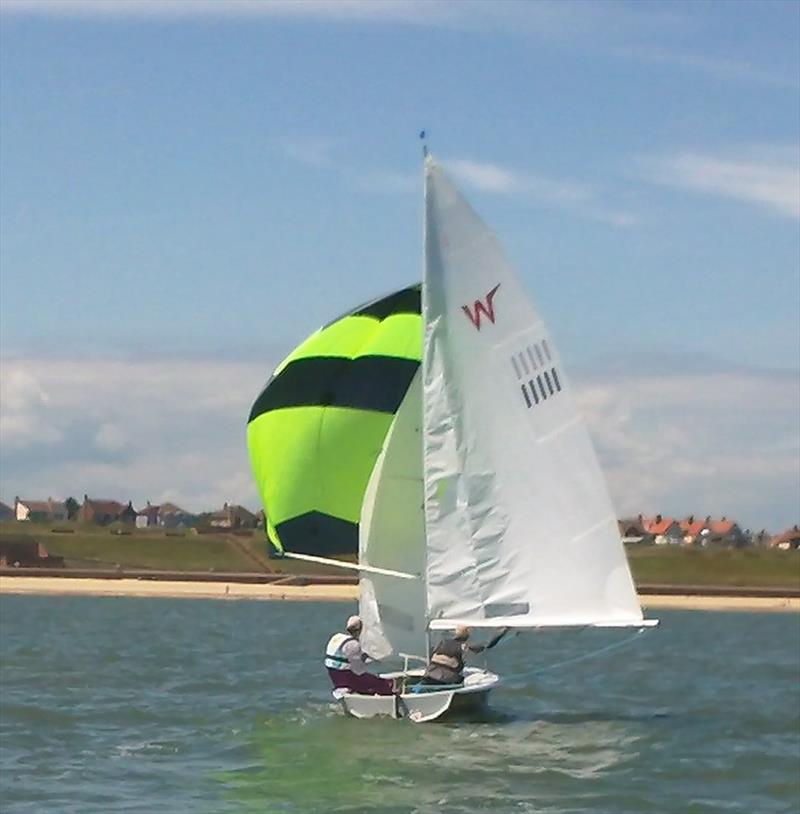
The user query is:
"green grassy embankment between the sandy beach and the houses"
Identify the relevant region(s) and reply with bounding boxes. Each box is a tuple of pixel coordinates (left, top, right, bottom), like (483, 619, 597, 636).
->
(0, 522, 800, 590)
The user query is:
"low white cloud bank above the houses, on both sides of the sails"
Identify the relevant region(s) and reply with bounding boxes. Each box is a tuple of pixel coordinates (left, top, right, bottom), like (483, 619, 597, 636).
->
(0, 359, 800, 530)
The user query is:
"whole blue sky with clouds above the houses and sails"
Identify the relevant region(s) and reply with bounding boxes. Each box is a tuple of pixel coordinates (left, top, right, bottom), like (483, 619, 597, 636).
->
(0, 0, 800, 531)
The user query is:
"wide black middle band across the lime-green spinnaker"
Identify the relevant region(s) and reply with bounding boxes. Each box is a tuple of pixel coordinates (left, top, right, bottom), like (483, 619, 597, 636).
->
(248, 356, 420, 421)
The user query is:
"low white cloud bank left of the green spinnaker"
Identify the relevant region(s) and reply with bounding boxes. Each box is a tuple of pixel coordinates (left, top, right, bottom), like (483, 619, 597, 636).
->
(0, 358, 276, 511)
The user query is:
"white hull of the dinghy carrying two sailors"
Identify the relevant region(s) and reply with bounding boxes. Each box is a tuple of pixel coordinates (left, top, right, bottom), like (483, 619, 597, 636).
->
(333, 667, 500, 724)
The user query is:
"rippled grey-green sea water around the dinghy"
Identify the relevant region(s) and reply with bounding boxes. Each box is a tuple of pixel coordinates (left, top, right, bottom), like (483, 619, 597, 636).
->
(0, 596, 800, 814)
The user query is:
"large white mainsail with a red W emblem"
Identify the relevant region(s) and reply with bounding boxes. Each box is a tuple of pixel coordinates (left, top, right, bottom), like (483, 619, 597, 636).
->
(423, 158, 642, 627)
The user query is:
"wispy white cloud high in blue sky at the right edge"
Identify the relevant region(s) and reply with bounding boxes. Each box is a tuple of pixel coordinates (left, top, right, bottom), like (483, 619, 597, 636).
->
(641, 148, 800, 219)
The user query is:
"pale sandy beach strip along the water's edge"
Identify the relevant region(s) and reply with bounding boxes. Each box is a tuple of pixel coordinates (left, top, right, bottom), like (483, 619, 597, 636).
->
(0, 576, 800, 612)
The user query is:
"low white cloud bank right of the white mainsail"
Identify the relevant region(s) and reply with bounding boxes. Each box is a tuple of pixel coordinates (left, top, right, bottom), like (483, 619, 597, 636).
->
(580, 364, 800, 530)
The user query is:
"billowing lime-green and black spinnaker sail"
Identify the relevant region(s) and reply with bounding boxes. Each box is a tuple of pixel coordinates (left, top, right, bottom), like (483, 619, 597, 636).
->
(247, 285, 422, 555)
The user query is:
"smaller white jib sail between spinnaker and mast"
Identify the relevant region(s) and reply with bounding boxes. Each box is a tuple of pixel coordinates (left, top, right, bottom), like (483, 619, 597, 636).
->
(359, 371, 427, 658)
